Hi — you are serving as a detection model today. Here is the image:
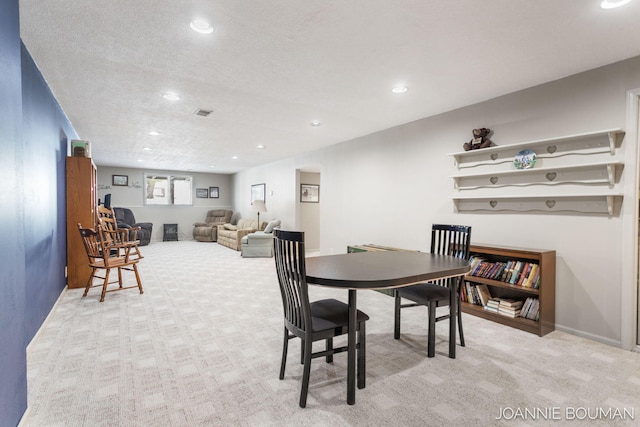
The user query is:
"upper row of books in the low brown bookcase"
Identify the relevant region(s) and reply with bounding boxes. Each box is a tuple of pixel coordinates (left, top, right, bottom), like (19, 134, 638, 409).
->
(469, 256, 540, 289)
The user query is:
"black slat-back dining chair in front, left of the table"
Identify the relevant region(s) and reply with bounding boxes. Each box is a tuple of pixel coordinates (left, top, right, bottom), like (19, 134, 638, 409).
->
(274, 229, 369, 408)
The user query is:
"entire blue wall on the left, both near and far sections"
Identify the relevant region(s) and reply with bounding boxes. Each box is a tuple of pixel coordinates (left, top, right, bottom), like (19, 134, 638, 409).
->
(0, 0, 77, 426)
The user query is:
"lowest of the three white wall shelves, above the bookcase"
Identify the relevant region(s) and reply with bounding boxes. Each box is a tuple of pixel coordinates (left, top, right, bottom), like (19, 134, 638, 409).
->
(453, 194, 622, 216)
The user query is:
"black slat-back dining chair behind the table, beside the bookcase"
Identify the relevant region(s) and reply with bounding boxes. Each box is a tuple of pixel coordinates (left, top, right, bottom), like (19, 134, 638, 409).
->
(393, 224, 471, 357)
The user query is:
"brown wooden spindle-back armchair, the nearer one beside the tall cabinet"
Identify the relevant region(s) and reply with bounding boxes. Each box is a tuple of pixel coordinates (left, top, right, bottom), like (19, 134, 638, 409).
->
(78, 224, 144, 302)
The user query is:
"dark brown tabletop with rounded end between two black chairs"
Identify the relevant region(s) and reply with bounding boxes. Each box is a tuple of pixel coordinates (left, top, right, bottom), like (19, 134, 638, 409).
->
(306, 251, 469, 290)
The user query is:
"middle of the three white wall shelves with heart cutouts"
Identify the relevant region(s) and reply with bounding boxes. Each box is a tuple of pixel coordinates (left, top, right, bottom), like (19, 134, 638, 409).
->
(451, 162, 624, 190)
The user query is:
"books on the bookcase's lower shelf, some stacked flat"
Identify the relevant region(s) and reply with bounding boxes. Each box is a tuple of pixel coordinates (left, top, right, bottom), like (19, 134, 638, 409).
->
(460, 282, 540, 320)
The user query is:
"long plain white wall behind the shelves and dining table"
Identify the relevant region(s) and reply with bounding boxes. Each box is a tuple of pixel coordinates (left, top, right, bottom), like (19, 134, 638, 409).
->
(233, 57, 640, 345)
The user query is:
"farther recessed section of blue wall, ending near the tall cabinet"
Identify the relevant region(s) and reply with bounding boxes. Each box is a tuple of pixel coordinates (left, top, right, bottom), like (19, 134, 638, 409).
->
(22, 46, 77, 341)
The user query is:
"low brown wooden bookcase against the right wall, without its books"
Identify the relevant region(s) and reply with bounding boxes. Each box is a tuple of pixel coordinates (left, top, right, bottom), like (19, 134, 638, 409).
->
(460, 244, 556, 336)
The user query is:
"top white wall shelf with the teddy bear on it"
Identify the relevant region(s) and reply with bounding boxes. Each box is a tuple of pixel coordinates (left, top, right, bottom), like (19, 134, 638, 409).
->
(449, 129, 625, 169)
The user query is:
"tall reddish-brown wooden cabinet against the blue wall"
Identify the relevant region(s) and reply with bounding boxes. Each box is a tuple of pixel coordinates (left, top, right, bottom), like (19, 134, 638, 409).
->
(66, 157, 97, 288)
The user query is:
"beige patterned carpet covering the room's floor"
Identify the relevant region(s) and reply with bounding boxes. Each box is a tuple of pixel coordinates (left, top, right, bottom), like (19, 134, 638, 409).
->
(22, 241, 640, 427)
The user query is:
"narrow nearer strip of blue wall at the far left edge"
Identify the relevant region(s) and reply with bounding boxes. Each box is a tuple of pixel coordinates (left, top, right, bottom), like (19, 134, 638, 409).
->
(0, 0, 27, 426)
